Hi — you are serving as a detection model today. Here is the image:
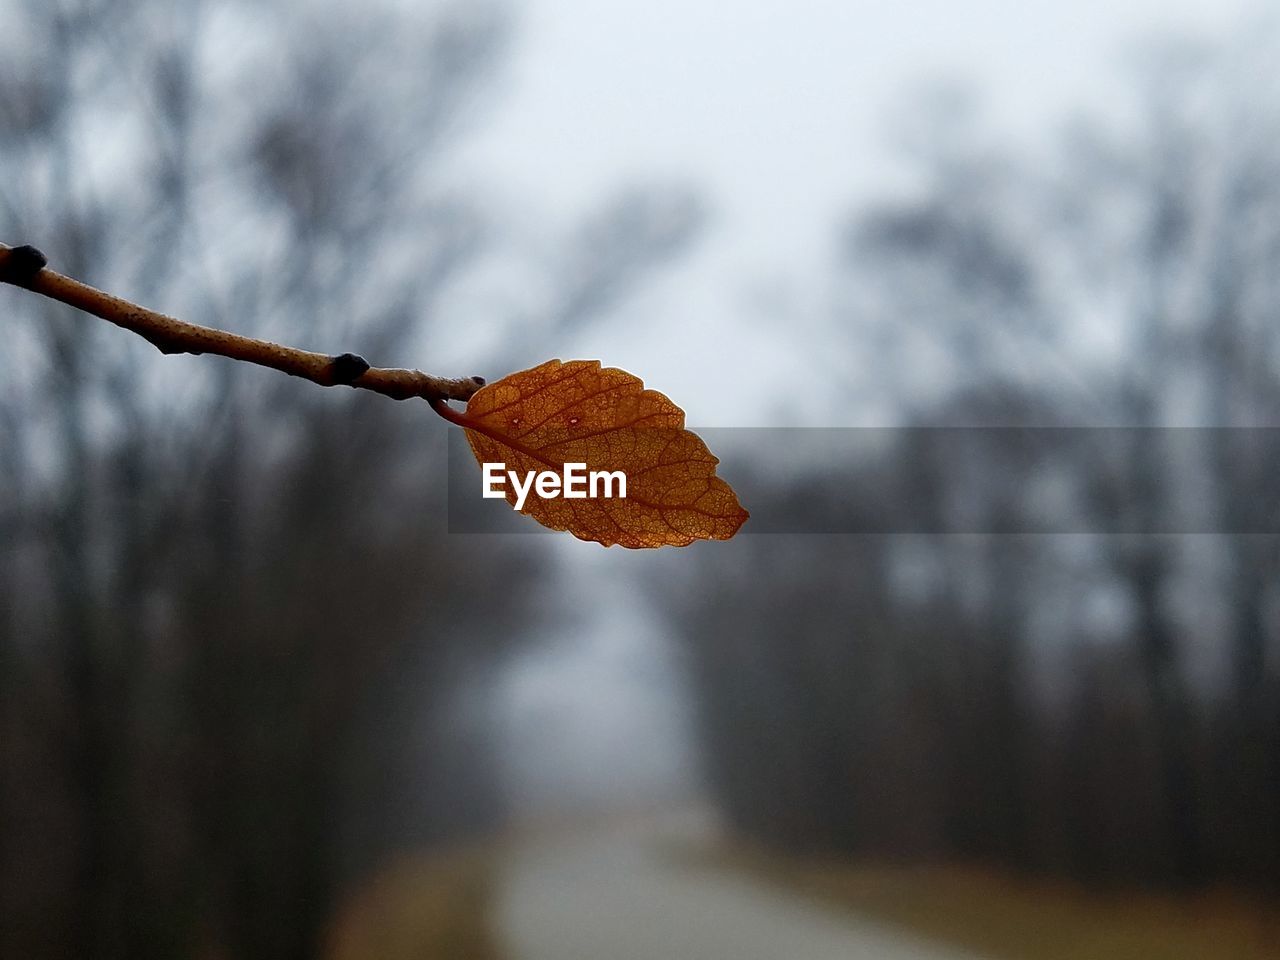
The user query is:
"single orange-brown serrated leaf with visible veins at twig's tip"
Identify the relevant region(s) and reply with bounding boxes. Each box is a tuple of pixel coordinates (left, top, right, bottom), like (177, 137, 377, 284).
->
(436, 360, 748, 547)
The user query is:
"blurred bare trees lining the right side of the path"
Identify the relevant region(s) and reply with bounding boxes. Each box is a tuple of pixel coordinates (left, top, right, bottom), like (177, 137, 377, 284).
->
(680, 37, 1280, 886)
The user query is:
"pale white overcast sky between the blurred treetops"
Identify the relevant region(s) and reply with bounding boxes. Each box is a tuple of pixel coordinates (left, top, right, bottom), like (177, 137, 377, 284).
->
(461, 0, 1258, 426)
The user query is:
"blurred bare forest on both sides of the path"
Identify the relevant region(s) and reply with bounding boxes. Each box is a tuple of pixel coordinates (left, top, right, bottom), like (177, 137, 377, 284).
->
(0, 0, 1280, 957)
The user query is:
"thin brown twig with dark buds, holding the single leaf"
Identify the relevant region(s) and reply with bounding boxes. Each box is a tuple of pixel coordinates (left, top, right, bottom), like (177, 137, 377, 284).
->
(0, 243, 484, 407)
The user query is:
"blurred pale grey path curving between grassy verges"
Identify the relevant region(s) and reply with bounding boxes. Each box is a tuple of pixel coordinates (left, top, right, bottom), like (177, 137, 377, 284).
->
(497, 824, 975, 960)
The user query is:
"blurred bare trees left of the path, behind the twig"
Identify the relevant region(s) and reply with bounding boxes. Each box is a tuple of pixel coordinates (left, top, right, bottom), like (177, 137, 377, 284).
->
(0, 0, 696, 957)
